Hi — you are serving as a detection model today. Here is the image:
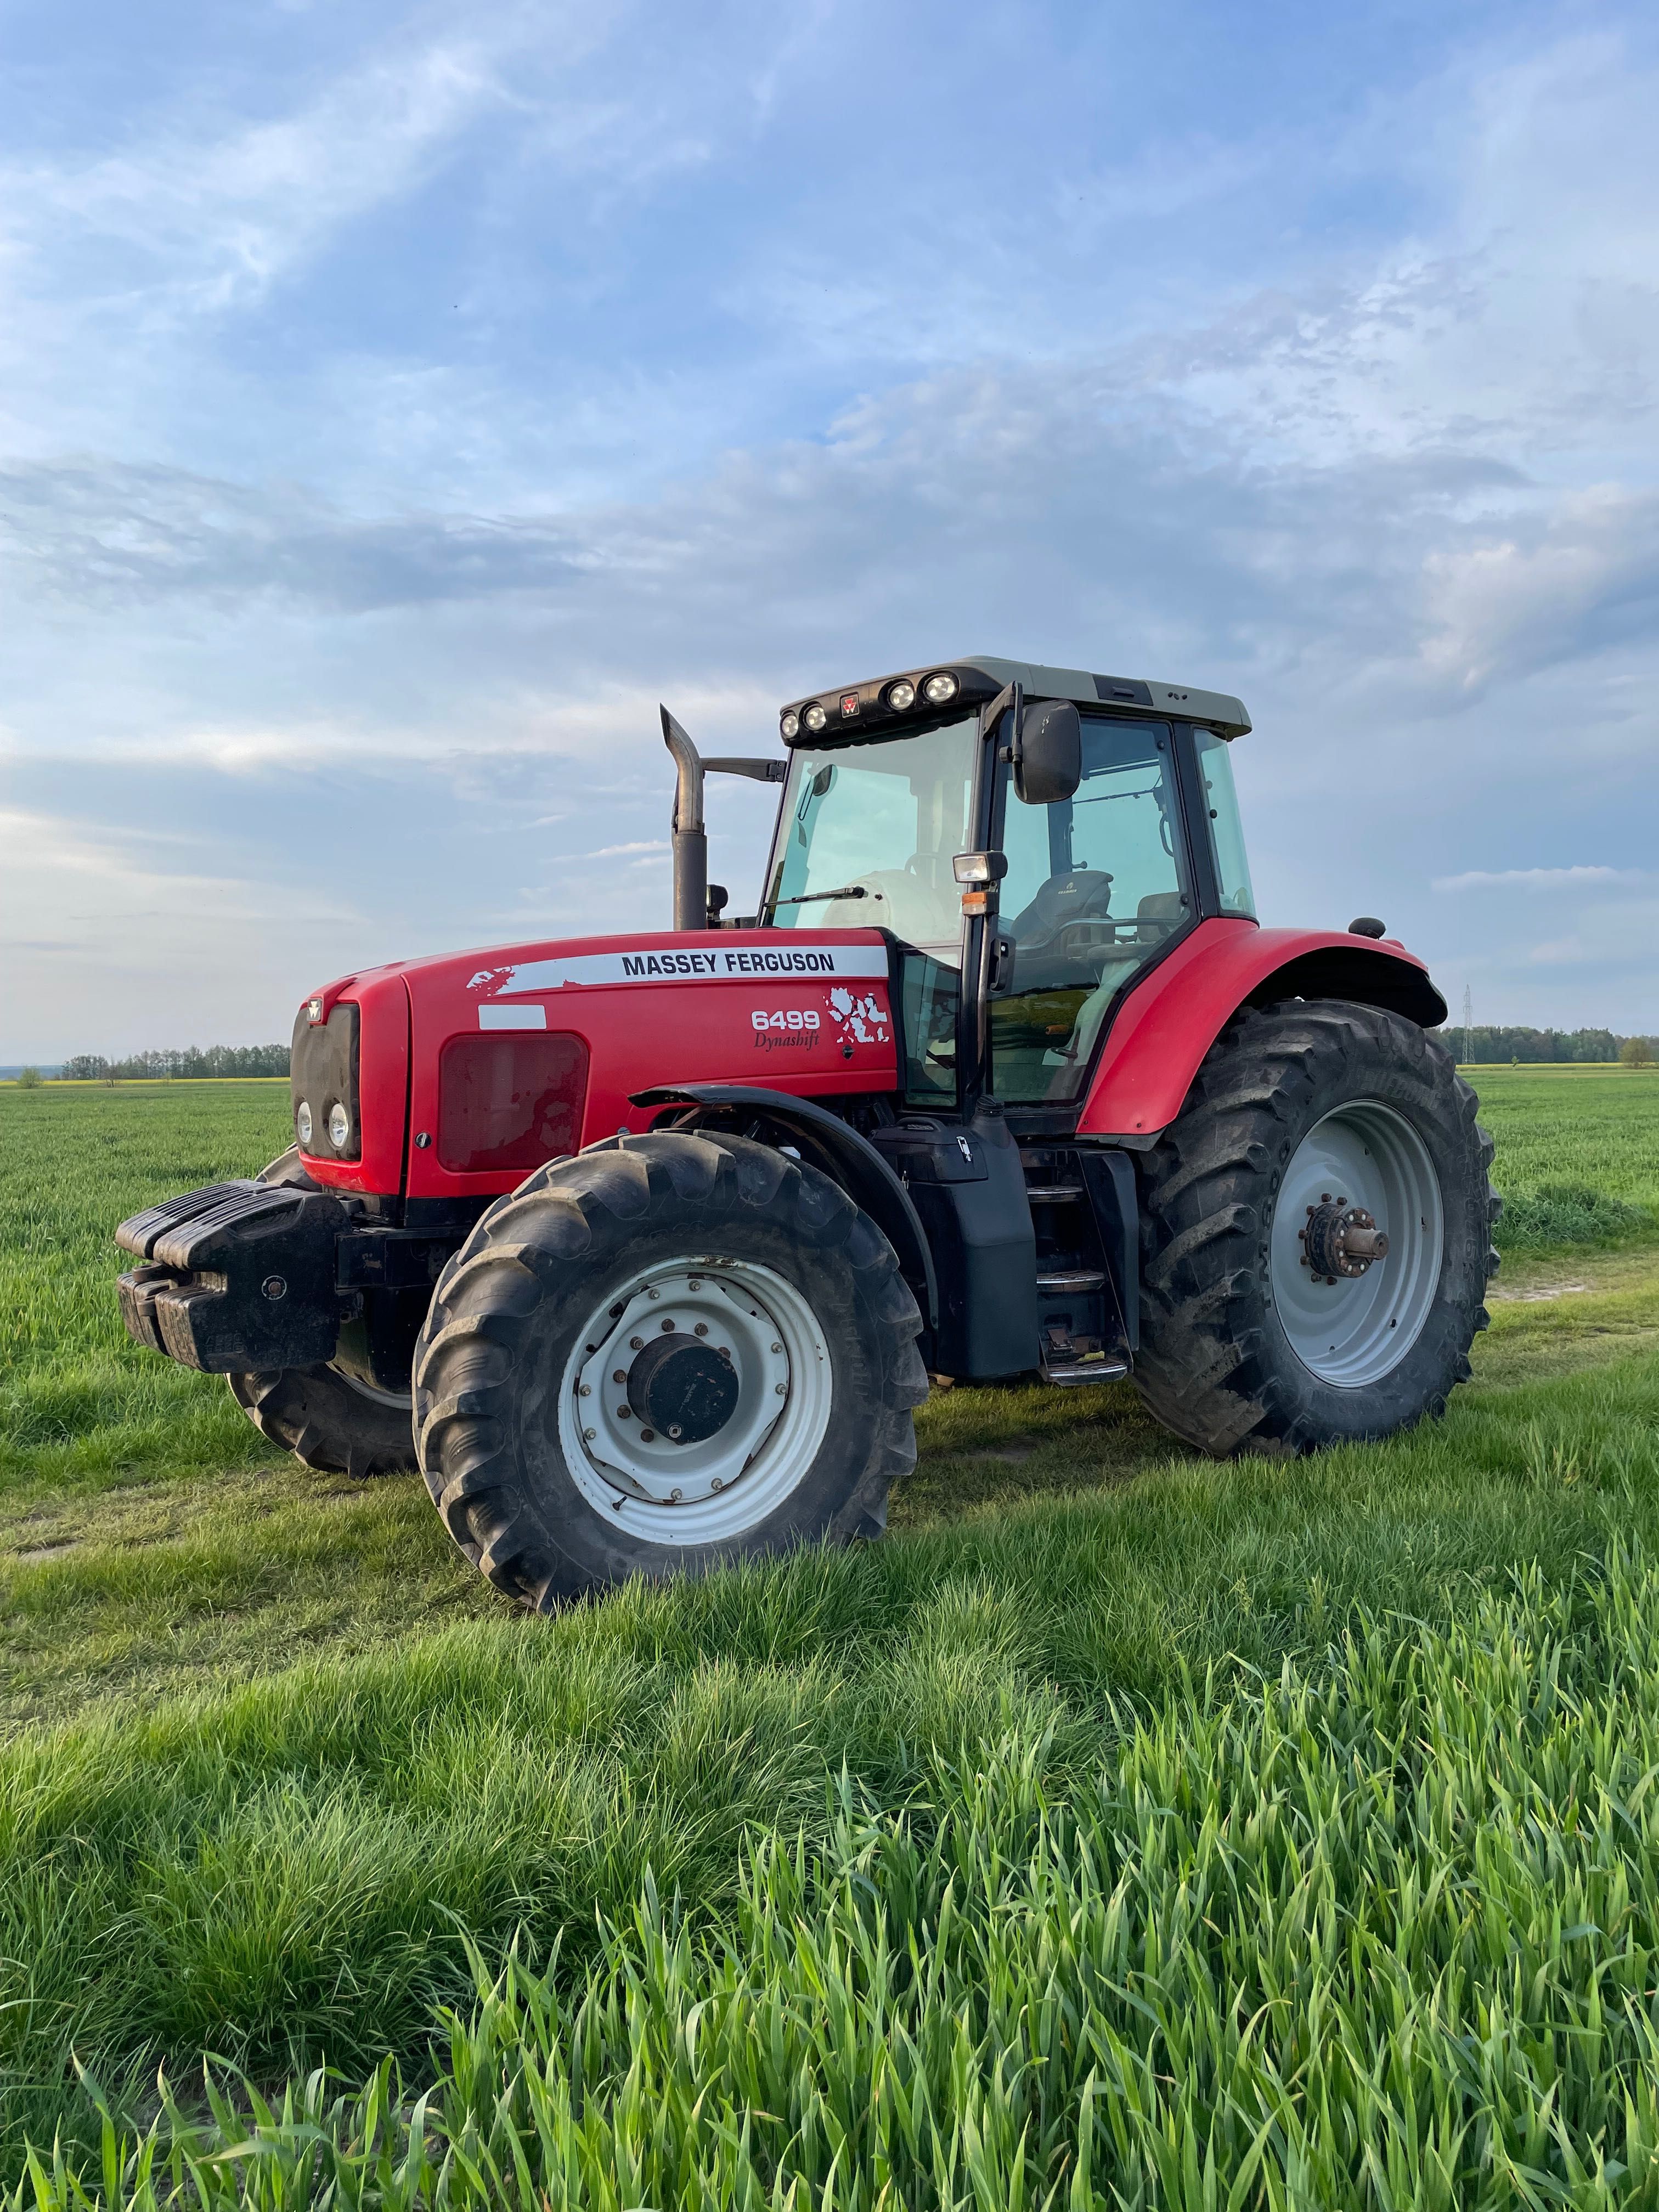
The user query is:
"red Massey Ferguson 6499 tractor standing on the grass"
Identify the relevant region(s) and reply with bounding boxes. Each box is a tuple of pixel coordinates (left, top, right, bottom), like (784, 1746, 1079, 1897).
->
(117, 657, 1498, 1606)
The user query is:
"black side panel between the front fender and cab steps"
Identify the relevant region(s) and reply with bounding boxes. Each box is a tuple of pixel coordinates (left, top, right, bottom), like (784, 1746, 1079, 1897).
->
(872, 1102, 1040, 1378)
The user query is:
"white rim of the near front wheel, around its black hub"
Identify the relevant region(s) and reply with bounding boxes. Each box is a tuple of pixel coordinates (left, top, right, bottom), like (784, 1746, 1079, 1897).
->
(560, 1256, 834, 1546)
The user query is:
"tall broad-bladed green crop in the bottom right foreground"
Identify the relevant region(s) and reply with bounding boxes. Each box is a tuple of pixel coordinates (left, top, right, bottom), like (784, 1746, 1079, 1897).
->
(26, 1548, 1659, 2212)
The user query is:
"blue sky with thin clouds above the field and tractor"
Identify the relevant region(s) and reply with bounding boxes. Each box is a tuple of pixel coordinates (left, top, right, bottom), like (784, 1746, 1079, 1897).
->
(0, 0, 1659, 1062)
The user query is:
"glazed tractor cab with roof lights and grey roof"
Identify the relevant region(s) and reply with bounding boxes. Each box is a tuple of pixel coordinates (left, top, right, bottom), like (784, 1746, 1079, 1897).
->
(759, 657, 1256, 1110)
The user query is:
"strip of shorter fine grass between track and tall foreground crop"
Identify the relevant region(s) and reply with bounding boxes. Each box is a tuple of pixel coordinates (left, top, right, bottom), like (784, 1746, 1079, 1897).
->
(0, 1358, 1659, 2154)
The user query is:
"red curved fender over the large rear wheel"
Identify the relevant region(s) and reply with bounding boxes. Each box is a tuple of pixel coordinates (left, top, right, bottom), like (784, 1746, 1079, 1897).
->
(1077, 918, 1447, 1146)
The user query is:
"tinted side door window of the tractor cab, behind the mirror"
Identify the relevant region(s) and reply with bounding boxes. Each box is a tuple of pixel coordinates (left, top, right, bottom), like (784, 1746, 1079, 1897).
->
(991, 716, 1192, 1102)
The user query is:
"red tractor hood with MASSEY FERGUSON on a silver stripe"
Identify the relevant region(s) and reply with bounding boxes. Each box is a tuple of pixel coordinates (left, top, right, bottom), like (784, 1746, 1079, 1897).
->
(294, 929, 898, 1199)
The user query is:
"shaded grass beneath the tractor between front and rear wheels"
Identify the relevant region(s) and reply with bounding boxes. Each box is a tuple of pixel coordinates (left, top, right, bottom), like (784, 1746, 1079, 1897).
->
(889, 1383, 1183, 1531)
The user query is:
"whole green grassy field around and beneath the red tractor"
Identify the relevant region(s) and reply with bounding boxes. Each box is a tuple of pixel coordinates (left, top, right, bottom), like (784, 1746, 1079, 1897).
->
(0, 1068, 1659, 2205)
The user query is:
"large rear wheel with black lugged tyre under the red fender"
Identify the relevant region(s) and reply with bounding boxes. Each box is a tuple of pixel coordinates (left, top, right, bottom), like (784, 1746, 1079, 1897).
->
(1135, 1000, 1500, 1458)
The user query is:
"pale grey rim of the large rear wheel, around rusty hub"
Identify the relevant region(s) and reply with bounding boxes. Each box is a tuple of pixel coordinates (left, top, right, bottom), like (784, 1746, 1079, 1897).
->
(1269, 1099, 1444, 1389)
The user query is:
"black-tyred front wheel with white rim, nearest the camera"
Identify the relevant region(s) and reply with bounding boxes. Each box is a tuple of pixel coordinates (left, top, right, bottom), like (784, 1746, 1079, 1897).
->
(416, 1130, 927, 1608)
